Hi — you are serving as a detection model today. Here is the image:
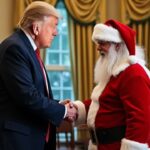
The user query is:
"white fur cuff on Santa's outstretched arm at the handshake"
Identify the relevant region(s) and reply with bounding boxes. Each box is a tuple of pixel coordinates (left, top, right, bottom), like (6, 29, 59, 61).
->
(74, 100, 86, 126)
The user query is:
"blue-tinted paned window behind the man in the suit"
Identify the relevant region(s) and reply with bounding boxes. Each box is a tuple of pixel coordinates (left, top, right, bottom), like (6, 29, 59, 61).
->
(45, 1, 74, 100)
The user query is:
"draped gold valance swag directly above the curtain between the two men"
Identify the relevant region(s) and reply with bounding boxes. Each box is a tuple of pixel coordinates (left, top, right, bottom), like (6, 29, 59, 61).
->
(64, 0, 100, 23)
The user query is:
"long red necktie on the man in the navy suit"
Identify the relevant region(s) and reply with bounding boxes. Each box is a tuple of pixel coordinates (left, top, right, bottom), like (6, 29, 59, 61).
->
(35, 48, 50, 142)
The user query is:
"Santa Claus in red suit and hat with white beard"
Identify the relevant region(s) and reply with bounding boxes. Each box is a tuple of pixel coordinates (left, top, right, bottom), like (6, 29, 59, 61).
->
(75, 20, 150, 150)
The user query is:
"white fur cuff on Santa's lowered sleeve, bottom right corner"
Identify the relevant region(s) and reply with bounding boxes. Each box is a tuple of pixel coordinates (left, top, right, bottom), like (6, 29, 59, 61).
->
(120, 138, 150, 150)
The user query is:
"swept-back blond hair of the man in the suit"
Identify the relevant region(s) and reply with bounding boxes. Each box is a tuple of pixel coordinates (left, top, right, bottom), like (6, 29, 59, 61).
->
(18, 1, 61, 29)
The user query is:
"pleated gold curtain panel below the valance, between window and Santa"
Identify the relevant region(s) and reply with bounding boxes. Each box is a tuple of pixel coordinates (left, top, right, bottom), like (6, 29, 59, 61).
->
(69, 18, 97, 100)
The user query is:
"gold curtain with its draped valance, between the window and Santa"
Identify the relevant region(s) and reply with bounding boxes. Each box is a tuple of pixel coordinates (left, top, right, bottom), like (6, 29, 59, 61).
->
(64, 0, 106, 101)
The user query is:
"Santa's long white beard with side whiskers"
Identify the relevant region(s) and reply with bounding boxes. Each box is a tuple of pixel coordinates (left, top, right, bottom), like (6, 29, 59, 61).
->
(94, 44, 129, 83)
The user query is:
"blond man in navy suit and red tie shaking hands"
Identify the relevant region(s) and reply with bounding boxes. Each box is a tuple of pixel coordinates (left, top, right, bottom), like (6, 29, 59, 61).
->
(0, 1, 76, 150)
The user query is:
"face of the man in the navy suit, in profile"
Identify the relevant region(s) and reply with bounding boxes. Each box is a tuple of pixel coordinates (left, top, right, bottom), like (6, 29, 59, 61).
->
(36, 16, 58, 48)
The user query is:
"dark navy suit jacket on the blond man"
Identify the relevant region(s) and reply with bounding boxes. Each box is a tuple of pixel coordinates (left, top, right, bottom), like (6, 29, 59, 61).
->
(0, 29, 65, 150)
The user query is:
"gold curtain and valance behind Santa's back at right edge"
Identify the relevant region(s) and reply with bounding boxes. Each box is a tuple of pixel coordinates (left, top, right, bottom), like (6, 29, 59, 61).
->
(121, 0, 150, 68)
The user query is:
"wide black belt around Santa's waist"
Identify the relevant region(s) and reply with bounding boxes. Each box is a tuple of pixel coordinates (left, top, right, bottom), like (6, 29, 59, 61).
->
(89, 126, 126, 145)
